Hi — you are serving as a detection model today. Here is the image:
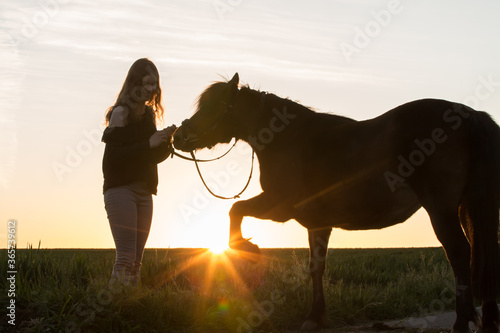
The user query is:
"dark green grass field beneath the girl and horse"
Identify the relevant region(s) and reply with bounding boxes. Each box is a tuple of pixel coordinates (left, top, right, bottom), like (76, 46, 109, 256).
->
(0, 248, 496, 332)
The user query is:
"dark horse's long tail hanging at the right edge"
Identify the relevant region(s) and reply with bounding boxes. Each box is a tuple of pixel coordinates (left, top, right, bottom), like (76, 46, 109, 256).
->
(460, 109, 500, 300)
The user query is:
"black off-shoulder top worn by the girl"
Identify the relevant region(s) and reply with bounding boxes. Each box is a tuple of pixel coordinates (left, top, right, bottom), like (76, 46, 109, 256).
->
(102, 112, 172, 194)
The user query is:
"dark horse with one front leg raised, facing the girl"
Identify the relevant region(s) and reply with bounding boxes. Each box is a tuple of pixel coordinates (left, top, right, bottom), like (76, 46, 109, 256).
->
(174, 74, 500, 332)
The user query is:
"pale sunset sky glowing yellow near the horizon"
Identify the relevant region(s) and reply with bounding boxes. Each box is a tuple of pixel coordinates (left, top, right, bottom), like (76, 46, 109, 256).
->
(0, 0, 500, 248)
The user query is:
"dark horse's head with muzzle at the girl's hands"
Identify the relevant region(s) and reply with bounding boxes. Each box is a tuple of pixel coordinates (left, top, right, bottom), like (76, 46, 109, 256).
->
(174, 73, 239, 152)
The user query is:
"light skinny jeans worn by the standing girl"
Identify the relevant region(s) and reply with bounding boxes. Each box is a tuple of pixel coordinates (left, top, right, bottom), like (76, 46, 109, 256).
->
(104, 182, 153, 285)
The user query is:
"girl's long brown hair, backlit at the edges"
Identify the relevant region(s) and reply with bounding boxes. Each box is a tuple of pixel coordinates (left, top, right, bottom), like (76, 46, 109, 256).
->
(106, 58, 164, 125)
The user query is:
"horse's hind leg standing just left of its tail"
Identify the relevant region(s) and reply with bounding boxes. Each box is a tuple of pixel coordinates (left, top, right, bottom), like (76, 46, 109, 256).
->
(426, 208, 479, 333)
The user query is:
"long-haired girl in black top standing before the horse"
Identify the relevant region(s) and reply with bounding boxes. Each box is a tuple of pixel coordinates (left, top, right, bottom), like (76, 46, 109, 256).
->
(102, 58, 175, 285)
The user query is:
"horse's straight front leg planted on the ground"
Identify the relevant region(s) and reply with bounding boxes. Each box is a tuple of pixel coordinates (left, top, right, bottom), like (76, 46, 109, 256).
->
(300, 228, 332, 331)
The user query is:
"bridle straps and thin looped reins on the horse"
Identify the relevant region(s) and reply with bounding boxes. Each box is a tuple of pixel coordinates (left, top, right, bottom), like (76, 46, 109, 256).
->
(173, 92, 266, 200)
